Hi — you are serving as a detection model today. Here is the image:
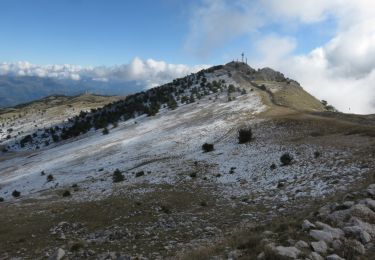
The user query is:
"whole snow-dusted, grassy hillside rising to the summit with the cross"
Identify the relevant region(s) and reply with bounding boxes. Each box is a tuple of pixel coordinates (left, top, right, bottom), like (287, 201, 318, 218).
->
(0, 63, 375, 259)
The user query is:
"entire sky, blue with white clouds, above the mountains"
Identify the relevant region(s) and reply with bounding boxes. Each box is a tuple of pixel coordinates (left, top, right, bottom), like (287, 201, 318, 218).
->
(0, 0, 375, 113)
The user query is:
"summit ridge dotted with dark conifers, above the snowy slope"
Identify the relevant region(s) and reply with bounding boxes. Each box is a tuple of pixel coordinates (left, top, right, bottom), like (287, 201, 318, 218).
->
(0, 62, 325, 150)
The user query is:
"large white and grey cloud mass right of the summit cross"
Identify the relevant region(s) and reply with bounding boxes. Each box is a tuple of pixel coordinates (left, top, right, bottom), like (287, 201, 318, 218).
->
(186, 0, 375, 113)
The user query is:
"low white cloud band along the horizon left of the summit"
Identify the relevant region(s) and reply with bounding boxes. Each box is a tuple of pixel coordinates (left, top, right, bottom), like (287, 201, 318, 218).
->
(0, 57, 208, 88)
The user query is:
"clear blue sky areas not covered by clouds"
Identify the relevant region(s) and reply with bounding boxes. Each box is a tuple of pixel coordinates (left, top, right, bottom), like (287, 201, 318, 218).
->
(0, 0, 333, 65)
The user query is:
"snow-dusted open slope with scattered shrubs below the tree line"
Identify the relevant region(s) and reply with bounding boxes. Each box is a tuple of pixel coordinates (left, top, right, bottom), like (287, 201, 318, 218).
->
(0, 87, 366, 207)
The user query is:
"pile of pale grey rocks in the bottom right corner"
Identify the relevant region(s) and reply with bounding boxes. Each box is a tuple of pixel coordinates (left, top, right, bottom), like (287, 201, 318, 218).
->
(262, 185, 375, 260)
